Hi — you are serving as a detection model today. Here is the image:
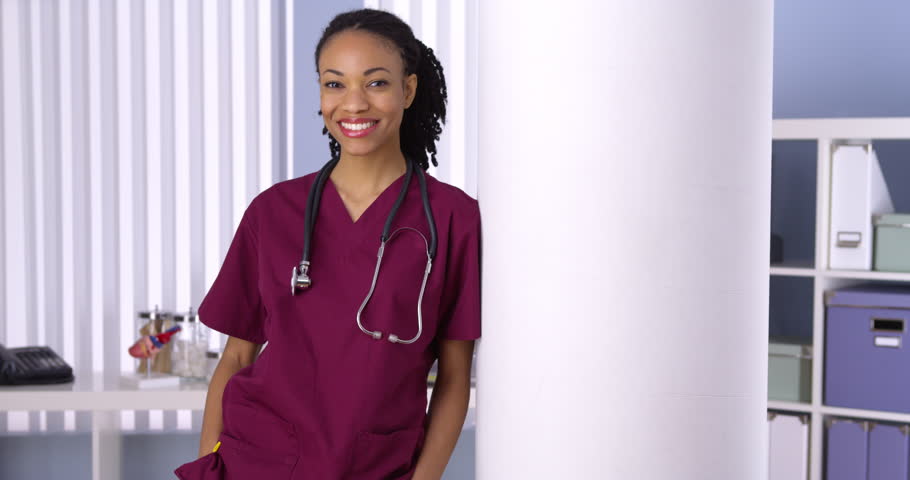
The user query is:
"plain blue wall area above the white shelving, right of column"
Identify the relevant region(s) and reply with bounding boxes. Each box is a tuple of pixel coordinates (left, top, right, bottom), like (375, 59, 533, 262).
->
(774, 0, 910, 118)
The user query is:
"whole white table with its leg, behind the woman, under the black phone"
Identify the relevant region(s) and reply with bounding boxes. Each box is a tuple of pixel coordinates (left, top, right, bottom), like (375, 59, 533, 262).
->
(0, 373, 477, 480)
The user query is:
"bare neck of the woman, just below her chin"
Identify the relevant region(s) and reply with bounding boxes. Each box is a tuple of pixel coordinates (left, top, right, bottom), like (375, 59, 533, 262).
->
(331, 145, 407, 195)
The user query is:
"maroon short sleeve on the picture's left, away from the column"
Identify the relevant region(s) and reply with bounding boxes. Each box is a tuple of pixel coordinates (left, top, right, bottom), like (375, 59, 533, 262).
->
(199, 206, 266, 344)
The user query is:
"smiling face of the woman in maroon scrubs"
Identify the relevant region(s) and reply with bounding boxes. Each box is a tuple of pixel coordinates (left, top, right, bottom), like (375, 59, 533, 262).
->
(319, 30, 417, 156)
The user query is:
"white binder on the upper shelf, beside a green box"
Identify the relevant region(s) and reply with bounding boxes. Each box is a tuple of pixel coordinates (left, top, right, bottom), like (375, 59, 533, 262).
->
(828, 144, 894, 270)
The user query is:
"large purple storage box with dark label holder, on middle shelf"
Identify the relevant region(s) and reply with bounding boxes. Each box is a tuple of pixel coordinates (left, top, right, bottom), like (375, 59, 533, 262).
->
(824, 286, 910, 413)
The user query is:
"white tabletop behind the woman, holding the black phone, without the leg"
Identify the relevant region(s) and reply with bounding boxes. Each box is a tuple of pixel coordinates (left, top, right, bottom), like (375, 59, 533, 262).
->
(0, 374, 477, 412)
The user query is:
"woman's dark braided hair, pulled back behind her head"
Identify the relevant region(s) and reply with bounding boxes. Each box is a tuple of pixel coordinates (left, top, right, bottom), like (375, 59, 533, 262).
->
(316, 8, 446, 170)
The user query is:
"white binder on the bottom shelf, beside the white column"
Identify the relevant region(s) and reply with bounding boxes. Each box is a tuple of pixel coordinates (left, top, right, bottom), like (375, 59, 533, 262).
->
(768, 413, 809, 480)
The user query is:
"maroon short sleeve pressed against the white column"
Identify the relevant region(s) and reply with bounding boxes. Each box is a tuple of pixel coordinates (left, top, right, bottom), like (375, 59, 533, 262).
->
(438, 202, 481, 340)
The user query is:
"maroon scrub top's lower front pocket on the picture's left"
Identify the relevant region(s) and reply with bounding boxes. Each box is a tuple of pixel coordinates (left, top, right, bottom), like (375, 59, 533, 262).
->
(217, 404, 298, 480)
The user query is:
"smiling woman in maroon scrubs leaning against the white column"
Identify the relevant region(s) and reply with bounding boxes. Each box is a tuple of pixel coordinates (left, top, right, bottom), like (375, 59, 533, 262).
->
(175, 9, 481, 480)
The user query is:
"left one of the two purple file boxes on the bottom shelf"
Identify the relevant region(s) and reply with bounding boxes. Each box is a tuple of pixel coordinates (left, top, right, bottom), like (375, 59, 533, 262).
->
(825, 418, 870, 480)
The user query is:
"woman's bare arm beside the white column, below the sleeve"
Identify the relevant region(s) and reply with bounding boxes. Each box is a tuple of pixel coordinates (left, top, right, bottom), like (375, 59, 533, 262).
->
(412, 340, 474, 480)
